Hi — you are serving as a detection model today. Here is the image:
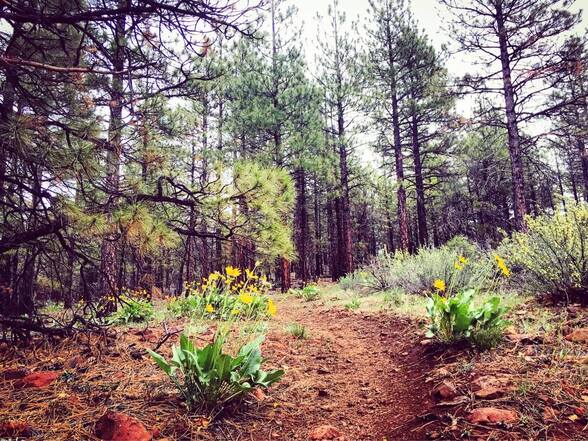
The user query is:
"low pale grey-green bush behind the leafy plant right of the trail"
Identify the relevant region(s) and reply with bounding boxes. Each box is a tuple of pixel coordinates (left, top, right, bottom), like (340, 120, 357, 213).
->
(364, 242, 489, 294)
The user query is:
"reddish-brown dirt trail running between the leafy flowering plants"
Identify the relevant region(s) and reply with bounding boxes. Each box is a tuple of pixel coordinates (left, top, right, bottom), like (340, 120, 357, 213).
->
(250, 297, 431, 441)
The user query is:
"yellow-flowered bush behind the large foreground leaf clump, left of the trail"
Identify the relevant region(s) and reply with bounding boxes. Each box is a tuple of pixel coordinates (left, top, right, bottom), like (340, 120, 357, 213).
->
(167, 266, 276, 320)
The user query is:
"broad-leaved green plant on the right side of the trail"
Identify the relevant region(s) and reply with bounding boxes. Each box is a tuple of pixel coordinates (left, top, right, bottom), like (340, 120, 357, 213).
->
(427, 289, 508, 349)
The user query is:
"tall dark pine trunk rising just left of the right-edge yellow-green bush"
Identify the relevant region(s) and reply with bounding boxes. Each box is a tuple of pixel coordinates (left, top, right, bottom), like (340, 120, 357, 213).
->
(496, 1, 527, 231)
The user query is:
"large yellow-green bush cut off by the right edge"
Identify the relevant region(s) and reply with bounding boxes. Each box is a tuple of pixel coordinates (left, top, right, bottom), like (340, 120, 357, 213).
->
(501, 203, 588, 303)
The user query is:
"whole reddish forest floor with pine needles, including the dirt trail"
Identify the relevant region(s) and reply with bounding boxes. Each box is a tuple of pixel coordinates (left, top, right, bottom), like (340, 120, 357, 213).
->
(0, 286, 588, 441)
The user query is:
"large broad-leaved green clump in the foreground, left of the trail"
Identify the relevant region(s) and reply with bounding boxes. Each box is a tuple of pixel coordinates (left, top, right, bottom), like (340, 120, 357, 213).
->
(149, 332, 284, 417)
